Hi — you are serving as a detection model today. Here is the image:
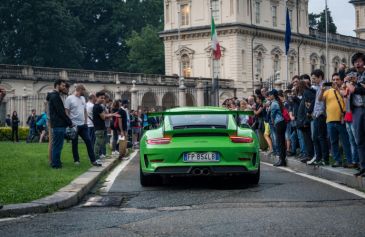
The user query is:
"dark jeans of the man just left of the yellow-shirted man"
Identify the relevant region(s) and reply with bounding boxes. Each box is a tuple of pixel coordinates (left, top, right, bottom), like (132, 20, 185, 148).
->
(312, 115, 329, 162)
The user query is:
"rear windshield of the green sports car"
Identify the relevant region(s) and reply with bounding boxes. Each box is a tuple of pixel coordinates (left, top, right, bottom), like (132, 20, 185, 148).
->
(169, 114, 228, 129)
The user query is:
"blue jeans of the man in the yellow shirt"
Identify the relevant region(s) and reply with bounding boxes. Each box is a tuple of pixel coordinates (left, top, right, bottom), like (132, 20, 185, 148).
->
(327, 122, 352, 164)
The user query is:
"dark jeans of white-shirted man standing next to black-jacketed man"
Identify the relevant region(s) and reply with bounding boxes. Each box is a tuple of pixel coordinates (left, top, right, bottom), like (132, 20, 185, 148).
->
(72, 125, 95, 163)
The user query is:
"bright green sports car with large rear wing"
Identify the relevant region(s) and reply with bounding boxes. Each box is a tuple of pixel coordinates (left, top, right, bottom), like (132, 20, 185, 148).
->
(140, 107, 260, 186)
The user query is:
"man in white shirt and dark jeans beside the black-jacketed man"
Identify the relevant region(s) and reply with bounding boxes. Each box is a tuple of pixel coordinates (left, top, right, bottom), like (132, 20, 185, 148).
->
(65, 84, 101, 166)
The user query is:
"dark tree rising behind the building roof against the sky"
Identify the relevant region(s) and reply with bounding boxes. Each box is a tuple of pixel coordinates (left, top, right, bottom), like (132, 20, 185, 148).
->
(309, 8, 337, 34)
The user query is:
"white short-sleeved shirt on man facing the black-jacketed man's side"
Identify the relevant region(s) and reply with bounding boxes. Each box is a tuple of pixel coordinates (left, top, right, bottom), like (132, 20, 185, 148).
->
(65, 95, 86, 126)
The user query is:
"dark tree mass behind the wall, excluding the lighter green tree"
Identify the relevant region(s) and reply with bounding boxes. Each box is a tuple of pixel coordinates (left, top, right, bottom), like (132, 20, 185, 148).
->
(0, 0, 163, 73)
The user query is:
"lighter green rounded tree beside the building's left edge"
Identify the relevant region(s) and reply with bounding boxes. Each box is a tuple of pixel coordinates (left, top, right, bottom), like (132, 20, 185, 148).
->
(126, 25, 165, 74)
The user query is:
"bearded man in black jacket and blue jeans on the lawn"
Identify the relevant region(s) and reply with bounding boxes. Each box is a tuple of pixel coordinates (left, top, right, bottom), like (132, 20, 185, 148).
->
(47, 79, 72, 169)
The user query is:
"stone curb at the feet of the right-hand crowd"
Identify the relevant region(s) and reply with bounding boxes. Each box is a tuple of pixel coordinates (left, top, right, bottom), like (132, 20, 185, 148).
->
(260, 152, 365, 191)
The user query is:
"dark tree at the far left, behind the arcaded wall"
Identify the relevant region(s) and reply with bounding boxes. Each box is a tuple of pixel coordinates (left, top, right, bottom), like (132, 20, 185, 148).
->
(0, 0, 83, 68)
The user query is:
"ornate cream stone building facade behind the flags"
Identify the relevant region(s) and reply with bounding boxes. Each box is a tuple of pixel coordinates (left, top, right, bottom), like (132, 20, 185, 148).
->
(160, 0, 365, 97)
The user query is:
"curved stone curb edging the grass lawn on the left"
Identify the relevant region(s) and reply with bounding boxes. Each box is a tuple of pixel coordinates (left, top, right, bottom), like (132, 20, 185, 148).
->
(0, 153, 138, 218)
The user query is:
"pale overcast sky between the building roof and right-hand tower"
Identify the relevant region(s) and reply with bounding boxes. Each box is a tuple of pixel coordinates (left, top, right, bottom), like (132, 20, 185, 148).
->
(309, 0, 355, 36)
